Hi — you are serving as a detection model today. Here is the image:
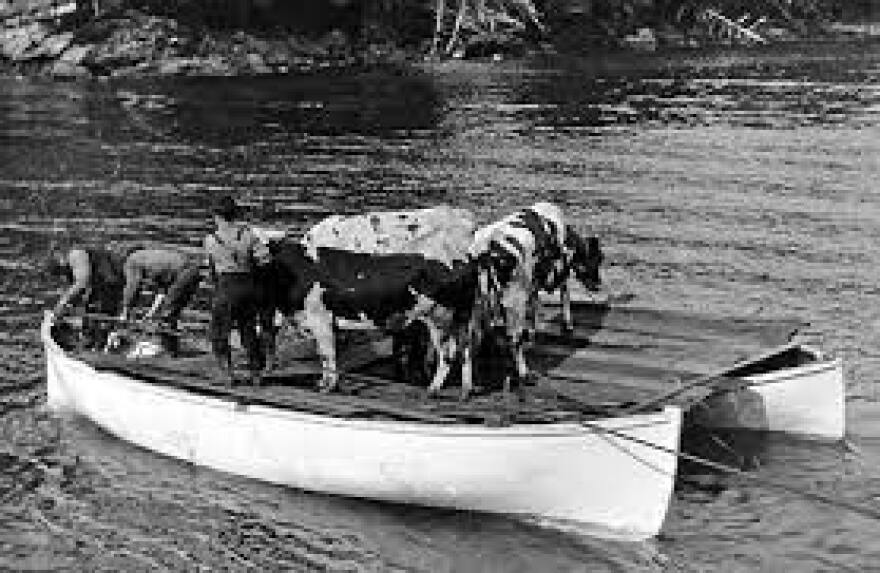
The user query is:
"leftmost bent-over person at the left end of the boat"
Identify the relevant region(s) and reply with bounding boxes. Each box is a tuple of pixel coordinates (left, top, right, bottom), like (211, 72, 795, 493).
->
(47, 242, 125, 349)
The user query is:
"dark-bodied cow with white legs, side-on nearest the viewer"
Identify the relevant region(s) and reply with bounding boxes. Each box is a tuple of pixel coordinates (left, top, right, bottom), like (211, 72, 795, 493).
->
(261, 240, 479, 399)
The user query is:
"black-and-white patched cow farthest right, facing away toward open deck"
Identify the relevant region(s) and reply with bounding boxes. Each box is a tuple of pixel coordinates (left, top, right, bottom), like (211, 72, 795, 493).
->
(471, 202, 603, 389)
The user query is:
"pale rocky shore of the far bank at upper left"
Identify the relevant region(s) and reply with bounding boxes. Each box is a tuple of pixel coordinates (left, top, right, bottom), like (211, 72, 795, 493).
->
(0, 1, 406, 78)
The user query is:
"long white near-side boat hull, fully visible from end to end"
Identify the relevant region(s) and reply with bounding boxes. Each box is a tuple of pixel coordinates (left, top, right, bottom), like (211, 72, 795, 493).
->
(42, 317, 681, 539)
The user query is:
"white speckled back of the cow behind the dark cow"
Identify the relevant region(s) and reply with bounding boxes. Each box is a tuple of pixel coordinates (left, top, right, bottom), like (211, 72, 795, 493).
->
(303, 205, 477, 265)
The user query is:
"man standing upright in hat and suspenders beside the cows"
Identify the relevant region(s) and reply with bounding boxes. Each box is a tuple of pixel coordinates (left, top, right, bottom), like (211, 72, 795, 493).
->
(204, 196, 265, 385)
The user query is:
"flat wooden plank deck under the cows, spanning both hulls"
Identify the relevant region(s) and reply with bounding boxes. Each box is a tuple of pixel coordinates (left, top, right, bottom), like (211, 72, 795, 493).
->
(67, 302, 810, 425)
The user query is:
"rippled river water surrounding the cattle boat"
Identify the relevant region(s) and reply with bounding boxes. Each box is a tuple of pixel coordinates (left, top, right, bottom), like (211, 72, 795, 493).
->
(0, 39, 880, 572)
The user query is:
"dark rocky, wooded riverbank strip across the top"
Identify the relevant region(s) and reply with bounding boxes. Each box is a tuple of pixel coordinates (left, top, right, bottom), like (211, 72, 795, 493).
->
(0, 0, 880, 76)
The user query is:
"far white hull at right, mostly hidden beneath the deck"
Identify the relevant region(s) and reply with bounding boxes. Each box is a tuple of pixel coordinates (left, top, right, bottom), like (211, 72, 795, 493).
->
(693, 348, 846, 440)
